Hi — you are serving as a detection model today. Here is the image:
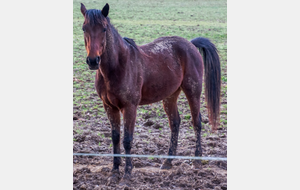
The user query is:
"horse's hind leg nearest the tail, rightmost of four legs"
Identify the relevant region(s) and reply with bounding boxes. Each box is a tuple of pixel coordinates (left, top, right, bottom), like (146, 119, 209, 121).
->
(181, 75, 202, 169)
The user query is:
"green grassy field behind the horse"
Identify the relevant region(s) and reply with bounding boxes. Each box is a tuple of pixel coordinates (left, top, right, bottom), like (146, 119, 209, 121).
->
(73, 0, 227, 127)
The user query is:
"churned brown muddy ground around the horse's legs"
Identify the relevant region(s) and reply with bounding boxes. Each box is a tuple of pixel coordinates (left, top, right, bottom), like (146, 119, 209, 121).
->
(73, 93, 227, 190)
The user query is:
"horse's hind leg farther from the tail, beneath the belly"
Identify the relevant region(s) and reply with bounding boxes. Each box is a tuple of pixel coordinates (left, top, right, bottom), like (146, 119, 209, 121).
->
(161, 88, 181, 169)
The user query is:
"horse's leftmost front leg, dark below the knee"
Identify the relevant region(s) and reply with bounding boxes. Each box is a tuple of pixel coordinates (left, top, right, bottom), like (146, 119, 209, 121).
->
(103, 102, 121, 181)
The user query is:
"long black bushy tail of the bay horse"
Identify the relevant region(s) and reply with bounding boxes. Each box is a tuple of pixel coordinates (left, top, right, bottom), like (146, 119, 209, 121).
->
(191, 38, 221, 131)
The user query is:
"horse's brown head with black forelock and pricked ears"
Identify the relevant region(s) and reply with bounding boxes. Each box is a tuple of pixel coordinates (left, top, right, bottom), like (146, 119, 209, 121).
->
(80, 3, 109, 70)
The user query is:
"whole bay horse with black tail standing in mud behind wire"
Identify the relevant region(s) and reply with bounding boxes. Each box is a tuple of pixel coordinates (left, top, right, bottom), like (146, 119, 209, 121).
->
(80, 4, 221, 184)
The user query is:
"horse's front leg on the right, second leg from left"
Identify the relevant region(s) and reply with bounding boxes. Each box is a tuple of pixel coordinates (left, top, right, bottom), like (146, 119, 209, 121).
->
(120, 105, 137, 185)
